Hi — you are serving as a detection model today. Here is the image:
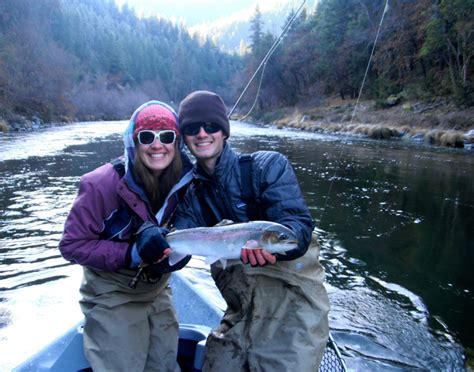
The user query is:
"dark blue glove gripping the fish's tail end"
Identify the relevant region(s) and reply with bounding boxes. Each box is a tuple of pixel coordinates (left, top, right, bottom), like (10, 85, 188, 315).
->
(131, 223, 170, 266)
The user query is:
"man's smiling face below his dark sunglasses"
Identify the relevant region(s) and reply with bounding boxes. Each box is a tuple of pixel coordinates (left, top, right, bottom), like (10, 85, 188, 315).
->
(184, 127, 224, 174)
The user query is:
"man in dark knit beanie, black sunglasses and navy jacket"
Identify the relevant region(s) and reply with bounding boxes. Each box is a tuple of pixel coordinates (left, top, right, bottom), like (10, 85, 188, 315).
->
(171, 91, 329, 371)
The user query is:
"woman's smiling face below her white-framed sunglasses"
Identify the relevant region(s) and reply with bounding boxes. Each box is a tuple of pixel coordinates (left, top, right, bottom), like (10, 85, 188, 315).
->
(137, 136, 176, 176)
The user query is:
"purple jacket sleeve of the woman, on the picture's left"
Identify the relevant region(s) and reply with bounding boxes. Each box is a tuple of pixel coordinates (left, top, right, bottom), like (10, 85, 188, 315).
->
(59, 172, 129, 271)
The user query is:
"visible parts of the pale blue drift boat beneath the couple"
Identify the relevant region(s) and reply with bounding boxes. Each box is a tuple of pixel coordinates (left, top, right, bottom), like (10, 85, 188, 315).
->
(13, 272, 346, 372)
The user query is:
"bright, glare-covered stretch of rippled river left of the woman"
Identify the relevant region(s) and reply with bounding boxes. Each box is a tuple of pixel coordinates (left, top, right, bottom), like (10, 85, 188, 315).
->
(0, 123, 128, 371)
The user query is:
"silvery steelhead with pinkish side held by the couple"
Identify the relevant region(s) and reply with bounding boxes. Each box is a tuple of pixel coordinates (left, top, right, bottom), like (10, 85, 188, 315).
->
(166, 221, 298, 268)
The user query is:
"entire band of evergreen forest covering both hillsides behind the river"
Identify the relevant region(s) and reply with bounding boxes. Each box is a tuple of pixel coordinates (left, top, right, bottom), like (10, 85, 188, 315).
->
(0, 0, 474, 128)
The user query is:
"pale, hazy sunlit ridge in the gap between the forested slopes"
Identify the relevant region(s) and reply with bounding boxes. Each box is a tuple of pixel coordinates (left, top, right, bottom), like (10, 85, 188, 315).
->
(189, 0, 317, 54)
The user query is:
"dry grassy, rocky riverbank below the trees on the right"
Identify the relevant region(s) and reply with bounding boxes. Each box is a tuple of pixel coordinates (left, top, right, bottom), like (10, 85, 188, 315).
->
(247, 98, 474, 150)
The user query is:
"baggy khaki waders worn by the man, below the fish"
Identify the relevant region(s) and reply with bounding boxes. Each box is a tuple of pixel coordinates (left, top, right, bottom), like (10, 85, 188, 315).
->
(203, 233, 329, 372)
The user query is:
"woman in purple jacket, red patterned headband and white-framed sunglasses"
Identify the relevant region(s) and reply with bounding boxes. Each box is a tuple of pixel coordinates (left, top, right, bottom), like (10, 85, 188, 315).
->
(59, 101, 191, 371)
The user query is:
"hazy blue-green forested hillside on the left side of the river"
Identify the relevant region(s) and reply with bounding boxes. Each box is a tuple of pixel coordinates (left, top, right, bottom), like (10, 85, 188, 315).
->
(0, 0, 241, 120)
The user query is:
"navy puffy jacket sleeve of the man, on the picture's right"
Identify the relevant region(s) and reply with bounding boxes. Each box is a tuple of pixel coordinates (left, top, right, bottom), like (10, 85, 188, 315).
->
(254, 151, 314, 261)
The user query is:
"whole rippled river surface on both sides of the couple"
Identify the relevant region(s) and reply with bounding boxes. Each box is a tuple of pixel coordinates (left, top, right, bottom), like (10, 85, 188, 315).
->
(0, 122, 474, 371)
